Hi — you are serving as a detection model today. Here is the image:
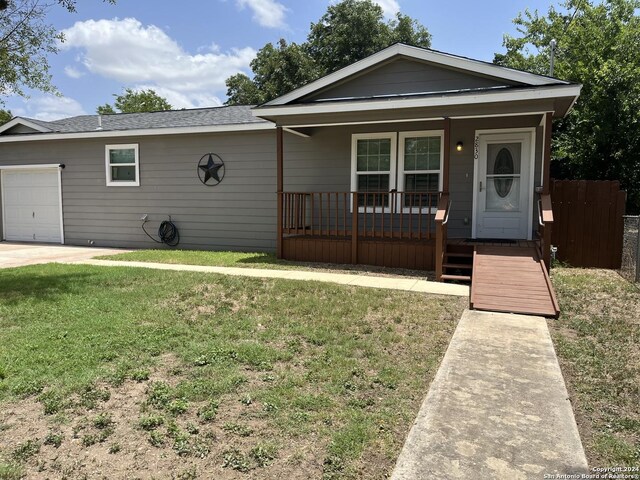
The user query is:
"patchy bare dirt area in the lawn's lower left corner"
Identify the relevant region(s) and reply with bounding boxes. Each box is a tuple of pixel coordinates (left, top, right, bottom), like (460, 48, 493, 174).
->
(0, 356, 326, 480)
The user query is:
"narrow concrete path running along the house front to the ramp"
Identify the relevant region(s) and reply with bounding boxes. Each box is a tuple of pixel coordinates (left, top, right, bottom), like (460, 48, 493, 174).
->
(72, 260, 469, 297)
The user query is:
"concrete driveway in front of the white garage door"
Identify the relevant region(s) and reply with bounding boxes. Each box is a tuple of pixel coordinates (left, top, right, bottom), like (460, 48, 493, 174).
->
(0, 242, 128, 268)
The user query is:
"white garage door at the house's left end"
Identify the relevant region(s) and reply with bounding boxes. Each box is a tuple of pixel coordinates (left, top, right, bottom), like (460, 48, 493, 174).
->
(2, 168, 63, 243)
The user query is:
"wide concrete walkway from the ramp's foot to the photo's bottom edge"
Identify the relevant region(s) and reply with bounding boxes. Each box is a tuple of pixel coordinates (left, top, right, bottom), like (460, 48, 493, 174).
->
(391, 310, 588, 480)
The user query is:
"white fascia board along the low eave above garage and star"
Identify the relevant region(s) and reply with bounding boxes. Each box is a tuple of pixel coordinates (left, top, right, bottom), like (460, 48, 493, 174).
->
(0, 122, 276, 143)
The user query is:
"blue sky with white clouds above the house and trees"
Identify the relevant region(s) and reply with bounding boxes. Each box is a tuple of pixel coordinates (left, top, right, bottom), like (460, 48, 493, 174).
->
(6, 0, 557, 120)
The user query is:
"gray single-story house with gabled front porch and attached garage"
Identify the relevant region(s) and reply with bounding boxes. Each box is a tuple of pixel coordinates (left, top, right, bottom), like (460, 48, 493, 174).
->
(0, 44, 581, 280)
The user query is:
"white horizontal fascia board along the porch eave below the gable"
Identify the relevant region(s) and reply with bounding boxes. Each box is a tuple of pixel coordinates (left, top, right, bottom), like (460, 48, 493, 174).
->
(254, 85, 582, 118)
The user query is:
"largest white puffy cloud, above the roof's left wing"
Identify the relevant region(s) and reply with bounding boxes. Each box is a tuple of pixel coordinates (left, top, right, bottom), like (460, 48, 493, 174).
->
(60, 18, 256, 108)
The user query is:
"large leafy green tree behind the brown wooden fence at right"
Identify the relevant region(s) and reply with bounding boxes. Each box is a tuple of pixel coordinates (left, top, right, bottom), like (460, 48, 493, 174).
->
(494, 0, 640, 213)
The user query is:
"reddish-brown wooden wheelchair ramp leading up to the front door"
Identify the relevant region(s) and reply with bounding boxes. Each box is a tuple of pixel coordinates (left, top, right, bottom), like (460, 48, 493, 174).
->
(470, 245, 560, 318)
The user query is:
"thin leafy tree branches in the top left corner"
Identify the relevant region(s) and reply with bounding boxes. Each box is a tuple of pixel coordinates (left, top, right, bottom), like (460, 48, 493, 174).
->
(0, 0, 115, 103)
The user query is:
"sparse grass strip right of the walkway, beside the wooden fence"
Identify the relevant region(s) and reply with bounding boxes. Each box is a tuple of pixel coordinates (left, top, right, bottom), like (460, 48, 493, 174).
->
(549, 268, 640, 467)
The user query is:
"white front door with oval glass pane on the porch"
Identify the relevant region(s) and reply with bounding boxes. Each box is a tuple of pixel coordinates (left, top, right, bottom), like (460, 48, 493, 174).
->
(473, 131, 533, 240)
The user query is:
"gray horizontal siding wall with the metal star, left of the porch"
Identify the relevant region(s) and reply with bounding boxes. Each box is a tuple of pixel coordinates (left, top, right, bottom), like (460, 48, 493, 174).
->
(0, 131, 276, 251)
